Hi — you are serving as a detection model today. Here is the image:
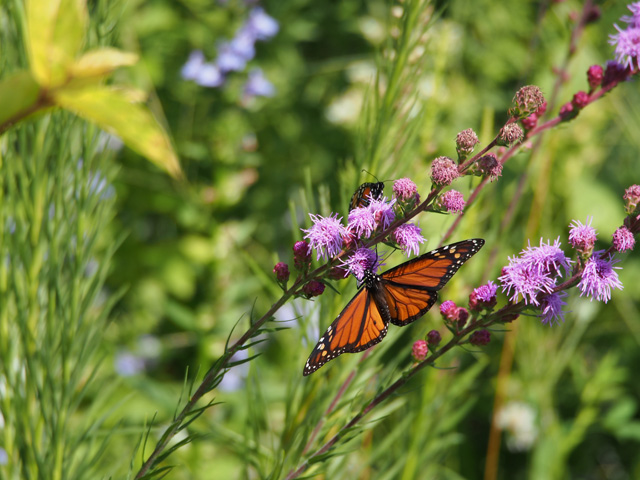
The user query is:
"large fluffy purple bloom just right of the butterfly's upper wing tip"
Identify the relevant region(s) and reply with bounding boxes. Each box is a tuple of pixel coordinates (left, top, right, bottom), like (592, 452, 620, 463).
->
(498, 239, 571, 306)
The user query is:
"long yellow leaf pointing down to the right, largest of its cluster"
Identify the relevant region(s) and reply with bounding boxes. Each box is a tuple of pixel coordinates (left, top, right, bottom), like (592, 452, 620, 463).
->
(54, 86, 182, 177)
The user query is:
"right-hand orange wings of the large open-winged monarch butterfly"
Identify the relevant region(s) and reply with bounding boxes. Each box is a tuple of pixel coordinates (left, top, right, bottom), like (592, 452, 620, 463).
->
(381, 238, 484, 327)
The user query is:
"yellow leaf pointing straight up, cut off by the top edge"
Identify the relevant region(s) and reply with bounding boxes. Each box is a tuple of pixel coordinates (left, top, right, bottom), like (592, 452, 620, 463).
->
(27, 0, 88, 87)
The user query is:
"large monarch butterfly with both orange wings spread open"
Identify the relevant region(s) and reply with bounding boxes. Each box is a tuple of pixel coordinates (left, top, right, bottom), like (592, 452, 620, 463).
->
(303, 238, 484, 376)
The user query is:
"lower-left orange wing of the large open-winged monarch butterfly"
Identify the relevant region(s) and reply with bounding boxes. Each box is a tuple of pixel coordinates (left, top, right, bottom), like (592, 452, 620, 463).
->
(303, 288, 389, 376)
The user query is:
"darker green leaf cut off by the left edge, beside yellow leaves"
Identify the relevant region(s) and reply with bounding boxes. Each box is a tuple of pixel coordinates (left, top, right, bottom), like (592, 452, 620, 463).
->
(0, 71, 40, 131)
